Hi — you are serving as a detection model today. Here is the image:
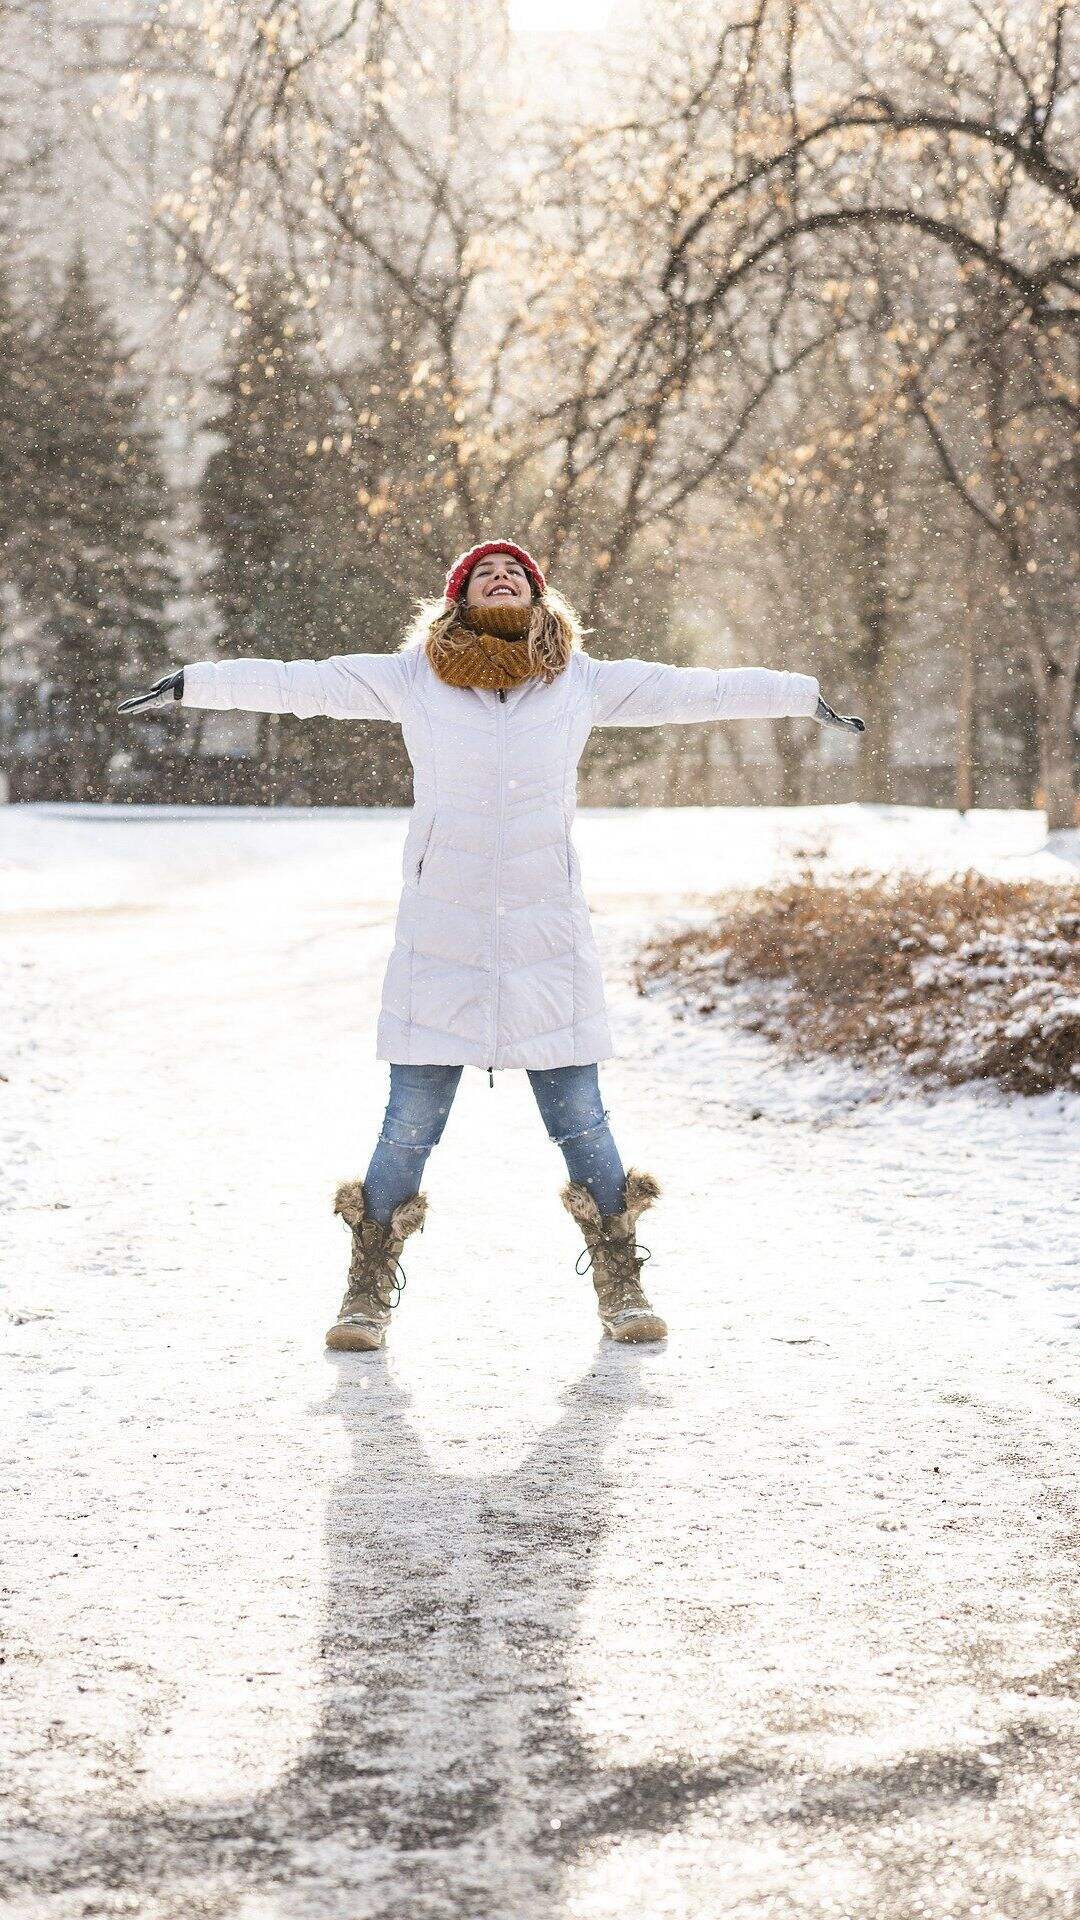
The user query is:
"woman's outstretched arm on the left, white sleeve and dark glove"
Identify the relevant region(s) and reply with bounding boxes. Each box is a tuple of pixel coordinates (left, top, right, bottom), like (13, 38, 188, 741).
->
(119, 653, 415, 720)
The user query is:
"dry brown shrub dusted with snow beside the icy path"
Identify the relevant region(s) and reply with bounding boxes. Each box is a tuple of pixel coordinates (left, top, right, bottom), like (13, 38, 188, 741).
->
(634, 874, 1080, 1094)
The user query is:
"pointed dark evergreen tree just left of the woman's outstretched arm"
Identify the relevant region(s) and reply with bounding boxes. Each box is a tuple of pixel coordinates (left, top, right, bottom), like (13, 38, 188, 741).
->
(19, 246, 177, 801)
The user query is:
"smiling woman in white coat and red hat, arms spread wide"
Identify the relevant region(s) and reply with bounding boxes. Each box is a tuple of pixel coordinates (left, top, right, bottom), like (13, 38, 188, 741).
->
(121, 540, 861, 1352)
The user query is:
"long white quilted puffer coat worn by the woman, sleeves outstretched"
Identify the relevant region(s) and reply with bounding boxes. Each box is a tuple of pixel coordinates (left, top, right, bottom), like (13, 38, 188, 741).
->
(183, 641, 819, 1069)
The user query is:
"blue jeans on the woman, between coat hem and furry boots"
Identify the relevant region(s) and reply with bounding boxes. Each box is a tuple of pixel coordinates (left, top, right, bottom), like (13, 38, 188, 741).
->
(363, 1064, 626, 1225)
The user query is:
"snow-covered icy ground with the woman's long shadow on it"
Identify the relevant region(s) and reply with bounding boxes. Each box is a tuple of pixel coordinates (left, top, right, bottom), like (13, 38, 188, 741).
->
(0, 808, 1080, 1920)
